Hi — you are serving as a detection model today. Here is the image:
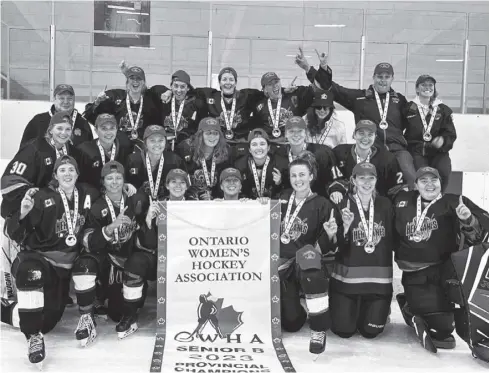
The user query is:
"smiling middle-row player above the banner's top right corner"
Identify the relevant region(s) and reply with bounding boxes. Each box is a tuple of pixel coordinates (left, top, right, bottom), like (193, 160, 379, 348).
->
(235, 128, 288, 199)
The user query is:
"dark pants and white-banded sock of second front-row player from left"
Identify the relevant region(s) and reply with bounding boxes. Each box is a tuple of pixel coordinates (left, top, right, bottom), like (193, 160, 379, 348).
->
(73, 253, 124, 322)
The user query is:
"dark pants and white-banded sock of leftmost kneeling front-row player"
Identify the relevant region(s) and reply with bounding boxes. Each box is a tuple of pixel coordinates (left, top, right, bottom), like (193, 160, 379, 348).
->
(12, 251, 70, 338)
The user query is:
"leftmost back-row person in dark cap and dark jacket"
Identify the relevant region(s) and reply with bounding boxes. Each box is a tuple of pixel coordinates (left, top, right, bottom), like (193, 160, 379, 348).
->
(20, 84, 93, 147)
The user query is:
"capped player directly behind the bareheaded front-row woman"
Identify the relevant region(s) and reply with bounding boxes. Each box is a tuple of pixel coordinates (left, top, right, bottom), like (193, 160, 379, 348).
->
(276, 117, 336, 198)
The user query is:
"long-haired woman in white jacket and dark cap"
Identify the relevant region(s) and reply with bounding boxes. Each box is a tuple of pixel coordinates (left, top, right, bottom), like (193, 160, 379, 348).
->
(304, 90, 346, 149)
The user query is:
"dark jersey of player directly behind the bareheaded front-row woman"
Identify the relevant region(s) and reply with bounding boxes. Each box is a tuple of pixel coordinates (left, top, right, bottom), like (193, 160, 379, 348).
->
(276, 143, 336, 198)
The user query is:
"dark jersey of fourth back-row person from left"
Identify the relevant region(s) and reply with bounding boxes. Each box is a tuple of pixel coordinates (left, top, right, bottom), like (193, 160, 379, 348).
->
(196, 88, 264, 142)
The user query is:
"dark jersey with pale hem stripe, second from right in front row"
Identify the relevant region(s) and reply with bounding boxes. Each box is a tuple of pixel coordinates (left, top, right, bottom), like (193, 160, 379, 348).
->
(330, 194, 394, 294)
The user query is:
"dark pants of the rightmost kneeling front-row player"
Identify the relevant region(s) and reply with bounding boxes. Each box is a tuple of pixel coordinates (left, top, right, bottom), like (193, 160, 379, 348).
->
(402, 264, 454, 340)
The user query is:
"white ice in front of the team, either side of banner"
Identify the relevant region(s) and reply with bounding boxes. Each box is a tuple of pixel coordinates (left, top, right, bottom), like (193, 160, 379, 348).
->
(0, 288, 489, 373)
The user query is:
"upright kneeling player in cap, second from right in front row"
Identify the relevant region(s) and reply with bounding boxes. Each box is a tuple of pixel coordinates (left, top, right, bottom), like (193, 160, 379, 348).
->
(329, 162, 393, 338)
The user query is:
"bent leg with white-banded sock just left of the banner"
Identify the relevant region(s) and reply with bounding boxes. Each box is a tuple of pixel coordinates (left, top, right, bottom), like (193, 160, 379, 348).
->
(122, 251, 157, 316)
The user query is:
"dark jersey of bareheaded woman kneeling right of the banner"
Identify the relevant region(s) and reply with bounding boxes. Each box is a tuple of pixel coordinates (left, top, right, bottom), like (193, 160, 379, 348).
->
(280, 189, 336, 259)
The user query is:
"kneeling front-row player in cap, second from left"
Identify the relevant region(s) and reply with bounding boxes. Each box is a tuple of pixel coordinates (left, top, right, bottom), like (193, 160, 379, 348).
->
(73, 161, 143, 346)
